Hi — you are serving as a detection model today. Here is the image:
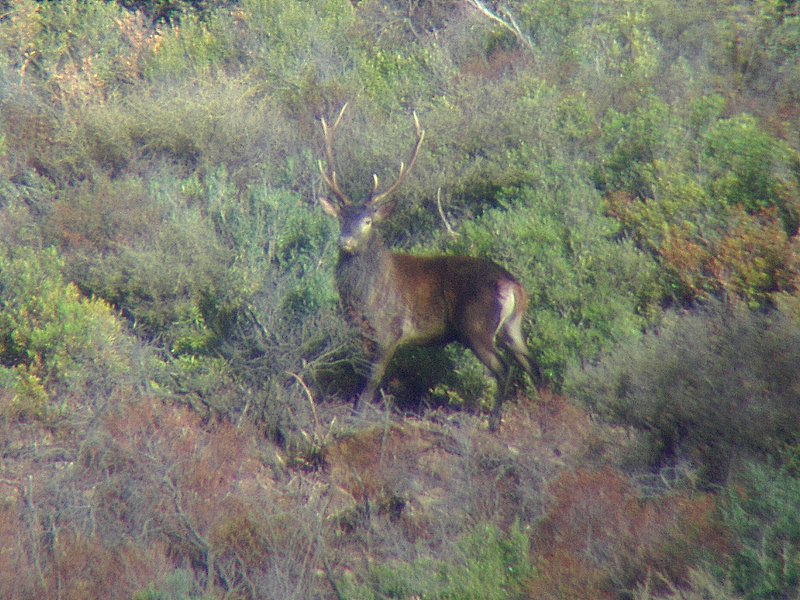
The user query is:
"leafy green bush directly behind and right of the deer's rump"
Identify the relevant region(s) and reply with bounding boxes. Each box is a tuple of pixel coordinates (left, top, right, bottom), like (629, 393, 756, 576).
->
(447, 184, 658, 387)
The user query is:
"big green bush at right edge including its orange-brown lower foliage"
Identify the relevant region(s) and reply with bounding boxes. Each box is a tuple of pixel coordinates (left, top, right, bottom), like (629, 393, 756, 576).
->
(595, 101, 800, 307)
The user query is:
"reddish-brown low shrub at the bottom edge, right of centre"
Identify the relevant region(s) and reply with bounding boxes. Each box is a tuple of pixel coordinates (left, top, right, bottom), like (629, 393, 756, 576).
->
(529, 467, 724, 600)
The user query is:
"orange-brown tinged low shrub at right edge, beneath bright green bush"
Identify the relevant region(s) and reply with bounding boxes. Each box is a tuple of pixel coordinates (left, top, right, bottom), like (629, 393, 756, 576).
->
(606, 170, 797, 308)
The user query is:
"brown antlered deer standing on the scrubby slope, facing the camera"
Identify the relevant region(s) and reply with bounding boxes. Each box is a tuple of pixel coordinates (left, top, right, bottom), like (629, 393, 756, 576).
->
(318, 103, 538, 431)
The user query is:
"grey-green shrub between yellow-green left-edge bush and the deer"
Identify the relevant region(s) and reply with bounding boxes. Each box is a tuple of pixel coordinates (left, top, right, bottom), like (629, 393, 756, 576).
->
(77, 170, 241, 353)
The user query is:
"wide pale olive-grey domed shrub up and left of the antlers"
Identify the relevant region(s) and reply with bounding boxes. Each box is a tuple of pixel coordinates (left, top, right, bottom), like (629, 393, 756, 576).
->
(79, 74, 288, 185)
